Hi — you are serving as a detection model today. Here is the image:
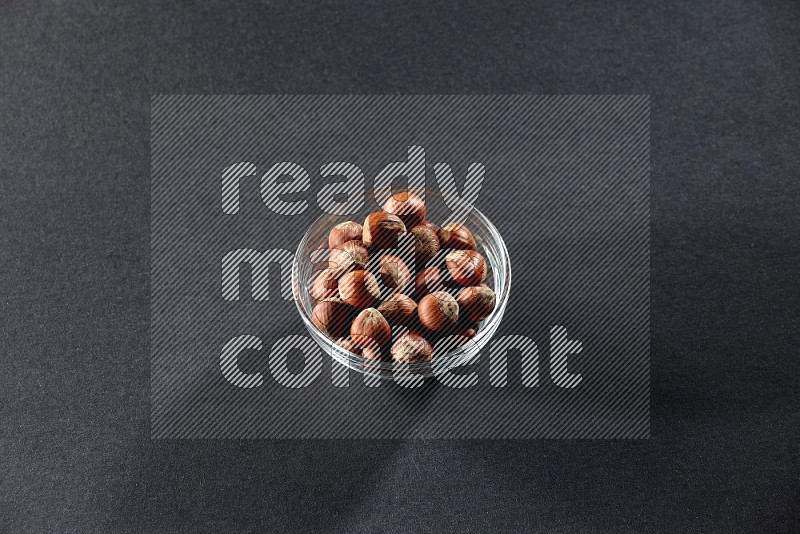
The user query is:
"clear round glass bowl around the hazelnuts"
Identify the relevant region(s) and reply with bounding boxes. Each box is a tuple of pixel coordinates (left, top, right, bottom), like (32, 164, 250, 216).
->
(292, 188, 511, 379)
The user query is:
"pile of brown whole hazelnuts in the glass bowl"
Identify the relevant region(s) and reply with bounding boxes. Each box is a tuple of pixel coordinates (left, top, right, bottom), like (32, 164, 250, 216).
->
(309, 192, 496, 364)
